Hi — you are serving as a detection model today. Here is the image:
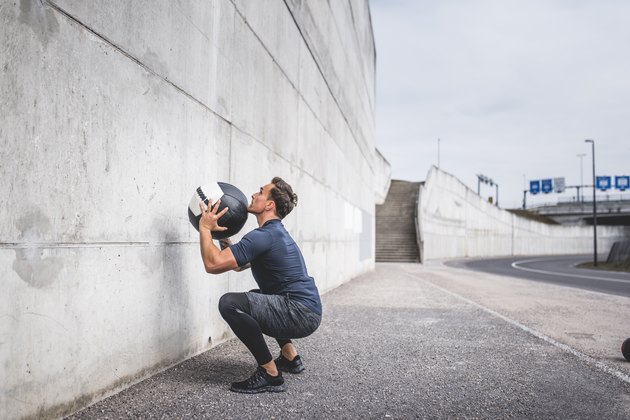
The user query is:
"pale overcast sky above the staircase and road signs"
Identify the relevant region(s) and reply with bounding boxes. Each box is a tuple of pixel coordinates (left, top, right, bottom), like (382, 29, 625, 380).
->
(370, 0, 630, 208)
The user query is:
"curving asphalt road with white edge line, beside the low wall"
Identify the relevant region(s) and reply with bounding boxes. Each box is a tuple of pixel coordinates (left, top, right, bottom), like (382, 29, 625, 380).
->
(445, 255, 630, 297)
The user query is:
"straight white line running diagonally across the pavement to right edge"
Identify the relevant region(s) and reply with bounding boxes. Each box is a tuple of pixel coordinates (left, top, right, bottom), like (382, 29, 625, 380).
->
(420, 273, 630, 384)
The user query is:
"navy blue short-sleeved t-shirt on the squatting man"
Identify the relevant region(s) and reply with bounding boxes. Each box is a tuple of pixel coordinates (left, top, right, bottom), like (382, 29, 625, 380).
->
(230, 219, 322, 315)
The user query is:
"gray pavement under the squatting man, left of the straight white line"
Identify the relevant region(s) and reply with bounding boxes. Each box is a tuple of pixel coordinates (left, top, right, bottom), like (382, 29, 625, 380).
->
(71, 264, 630, 419)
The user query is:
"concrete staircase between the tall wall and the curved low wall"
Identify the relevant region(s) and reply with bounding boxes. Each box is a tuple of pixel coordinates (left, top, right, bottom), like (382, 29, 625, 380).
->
(376, 180, 420, 262)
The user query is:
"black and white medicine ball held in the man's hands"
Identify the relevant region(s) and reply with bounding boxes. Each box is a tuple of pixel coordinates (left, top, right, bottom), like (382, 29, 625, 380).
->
(188, 182, 248, 239)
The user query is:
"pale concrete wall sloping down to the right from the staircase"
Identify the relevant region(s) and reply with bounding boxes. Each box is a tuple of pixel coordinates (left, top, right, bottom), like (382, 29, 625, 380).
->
(419, 167, 630, 261)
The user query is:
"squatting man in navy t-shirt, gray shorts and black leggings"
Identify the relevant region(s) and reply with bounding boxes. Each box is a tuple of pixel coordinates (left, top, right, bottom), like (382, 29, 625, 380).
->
(199, 177, 322, 394)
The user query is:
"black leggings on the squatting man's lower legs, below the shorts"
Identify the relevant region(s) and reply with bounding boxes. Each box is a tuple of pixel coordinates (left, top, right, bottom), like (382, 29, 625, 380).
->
(219, 293, 291, 365)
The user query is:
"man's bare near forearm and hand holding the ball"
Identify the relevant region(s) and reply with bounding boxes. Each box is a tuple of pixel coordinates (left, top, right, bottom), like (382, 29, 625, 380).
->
(199, 200, 238, 274)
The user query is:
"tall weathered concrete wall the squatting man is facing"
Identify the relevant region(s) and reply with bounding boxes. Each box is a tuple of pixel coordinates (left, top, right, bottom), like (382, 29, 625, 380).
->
(0, 0, 380, 418)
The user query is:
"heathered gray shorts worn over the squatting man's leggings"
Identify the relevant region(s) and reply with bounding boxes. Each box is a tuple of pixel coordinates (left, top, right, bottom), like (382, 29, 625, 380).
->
(245, 292, 322, 339)
